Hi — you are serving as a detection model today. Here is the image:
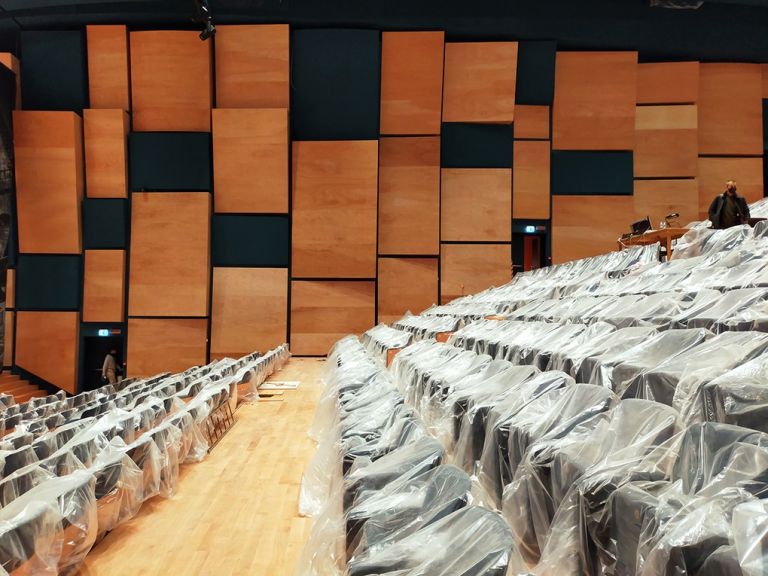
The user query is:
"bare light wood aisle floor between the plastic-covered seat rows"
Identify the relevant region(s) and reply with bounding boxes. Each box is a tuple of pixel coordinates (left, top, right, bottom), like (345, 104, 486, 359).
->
(79, 359, 324, 576)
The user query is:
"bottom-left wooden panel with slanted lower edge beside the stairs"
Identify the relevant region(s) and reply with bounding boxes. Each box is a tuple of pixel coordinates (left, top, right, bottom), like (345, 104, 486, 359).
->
(15, 312, 80, 394)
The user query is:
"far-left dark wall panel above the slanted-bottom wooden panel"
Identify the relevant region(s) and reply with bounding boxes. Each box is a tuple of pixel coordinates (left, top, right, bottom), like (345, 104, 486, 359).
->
(16, 254, 81, 310)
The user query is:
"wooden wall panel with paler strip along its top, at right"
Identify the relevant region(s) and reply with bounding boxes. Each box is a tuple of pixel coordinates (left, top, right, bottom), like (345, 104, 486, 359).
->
(634, 104, 699, 178)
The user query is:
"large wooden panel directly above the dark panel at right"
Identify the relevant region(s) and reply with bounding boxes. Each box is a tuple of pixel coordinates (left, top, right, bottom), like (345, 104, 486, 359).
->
(552, 52, 637, 150)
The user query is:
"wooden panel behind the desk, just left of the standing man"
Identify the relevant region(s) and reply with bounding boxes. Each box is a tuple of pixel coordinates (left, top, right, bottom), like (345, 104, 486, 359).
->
(633, 178, 699, 228)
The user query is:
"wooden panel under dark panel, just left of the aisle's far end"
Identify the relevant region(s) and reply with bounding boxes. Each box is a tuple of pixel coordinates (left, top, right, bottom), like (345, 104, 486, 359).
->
(211, 268, 288, 358)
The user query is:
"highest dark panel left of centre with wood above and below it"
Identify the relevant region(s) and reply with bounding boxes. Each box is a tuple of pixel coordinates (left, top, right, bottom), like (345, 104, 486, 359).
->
(128, 132, 211, 192)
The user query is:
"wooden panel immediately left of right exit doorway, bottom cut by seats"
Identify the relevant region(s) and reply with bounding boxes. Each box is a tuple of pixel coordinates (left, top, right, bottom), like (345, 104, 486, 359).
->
(440, 244, 512, 303)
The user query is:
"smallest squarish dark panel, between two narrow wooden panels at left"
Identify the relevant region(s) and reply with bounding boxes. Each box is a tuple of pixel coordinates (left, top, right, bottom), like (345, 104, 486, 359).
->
(83, 198, 128, 250)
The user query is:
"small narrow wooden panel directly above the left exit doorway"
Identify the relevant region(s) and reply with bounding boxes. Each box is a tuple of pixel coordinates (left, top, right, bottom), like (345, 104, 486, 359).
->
(83, 250, 125, 322)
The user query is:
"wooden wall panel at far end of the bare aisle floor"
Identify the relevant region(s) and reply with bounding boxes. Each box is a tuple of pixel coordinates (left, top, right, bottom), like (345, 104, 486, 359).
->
(291, 280, 376, 356)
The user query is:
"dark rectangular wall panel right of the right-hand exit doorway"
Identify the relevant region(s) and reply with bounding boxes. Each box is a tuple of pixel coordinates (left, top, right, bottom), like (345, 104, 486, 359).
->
(552, 150, 634, 195)
